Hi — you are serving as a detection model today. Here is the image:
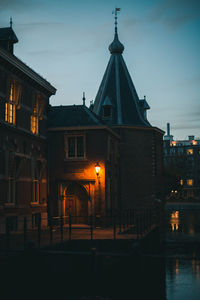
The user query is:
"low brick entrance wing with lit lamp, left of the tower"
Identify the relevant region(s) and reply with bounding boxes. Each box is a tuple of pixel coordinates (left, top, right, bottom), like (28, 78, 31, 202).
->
(48, 105, 119, 217)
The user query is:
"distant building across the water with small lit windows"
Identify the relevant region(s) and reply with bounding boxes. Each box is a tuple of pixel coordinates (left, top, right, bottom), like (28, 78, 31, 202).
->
(163, 123, 200, 201)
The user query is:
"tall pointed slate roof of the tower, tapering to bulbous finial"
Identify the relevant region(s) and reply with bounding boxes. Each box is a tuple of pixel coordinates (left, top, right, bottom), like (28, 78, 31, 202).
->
(93, 32, 151, 126)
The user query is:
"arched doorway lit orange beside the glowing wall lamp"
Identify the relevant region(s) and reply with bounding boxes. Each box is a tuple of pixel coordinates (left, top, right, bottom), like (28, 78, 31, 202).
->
(63, 182, 90, 222)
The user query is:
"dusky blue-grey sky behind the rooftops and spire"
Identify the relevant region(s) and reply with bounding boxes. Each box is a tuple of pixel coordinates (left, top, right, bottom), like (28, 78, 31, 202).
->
(0, 0, 200, 140)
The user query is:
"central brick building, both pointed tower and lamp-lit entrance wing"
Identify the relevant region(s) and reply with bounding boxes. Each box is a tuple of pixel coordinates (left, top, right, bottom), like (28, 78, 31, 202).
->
(48, 19, 164, 220)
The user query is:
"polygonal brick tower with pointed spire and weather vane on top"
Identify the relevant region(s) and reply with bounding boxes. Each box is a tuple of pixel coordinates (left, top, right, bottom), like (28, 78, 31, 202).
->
(92, 8, 164, 209)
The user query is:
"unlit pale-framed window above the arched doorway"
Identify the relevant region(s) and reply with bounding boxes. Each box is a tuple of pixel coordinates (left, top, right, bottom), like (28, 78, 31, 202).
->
(67, 136, 85, 158)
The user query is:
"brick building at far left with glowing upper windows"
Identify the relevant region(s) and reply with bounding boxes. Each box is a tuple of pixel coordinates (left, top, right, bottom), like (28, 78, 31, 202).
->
(0, 26, 56, 231)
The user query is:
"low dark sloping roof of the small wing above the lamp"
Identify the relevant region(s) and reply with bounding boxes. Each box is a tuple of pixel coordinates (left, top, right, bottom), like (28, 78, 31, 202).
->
(48, 105, 105, 128)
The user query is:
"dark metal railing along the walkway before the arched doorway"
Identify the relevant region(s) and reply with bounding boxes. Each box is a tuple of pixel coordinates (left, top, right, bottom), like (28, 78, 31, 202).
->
(0, 208, 157, 253)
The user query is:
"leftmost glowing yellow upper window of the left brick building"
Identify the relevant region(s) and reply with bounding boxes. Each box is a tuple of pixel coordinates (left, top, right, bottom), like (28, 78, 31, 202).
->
(5, 80, 21, 125)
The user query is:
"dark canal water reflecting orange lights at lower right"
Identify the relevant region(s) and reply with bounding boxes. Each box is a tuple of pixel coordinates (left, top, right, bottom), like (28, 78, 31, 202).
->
(165, 206, 200, 300)
